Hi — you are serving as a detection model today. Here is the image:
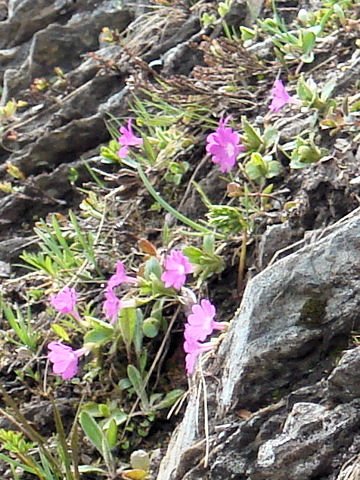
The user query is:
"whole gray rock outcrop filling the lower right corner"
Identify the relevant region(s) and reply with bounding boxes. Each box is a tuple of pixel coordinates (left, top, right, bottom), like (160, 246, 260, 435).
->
(158, 210, 360, 480)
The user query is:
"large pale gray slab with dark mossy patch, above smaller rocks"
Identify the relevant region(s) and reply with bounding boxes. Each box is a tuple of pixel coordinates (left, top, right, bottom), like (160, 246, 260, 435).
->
(216, 209, 360, 412)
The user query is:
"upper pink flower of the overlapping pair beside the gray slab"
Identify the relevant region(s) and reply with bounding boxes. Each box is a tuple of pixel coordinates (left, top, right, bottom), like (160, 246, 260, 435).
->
(185, 299, 226, 341)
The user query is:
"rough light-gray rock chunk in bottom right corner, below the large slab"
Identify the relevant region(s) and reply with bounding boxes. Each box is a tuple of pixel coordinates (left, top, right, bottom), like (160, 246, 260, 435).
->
(252, 403, 360, 480)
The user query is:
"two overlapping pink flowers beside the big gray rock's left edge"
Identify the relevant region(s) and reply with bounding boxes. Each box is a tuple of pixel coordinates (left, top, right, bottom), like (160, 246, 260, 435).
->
(184, 299, 226, 375)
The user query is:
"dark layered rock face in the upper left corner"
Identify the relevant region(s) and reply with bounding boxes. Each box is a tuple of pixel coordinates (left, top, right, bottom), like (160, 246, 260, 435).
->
(0, 0, 136, 233)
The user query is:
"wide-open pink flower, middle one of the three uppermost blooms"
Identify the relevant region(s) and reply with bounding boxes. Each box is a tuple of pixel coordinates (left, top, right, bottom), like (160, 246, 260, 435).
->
(206, 117, 245, 172)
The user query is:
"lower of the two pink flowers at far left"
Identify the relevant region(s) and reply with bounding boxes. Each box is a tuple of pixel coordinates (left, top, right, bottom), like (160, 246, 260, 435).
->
(47, 342, 87, 380)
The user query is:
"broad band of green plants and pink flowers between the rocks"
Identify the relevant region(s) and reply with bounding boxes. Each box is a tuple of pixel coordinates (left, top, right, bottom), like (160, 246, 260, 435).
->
(0, 0, 360, 472)
